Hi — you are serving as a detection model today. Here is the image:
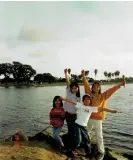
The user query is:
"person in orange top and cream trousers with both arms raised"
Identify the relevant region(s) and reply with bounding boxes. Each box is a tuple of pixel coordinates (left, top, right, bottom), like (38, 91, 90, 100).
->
(81, 70, 125, 160)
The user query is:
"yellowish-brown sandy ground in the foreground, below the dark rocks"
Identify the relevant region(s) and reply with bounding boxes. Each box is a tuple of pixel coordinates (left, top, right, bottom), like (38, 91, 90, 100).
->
(0, 142, 129, 160)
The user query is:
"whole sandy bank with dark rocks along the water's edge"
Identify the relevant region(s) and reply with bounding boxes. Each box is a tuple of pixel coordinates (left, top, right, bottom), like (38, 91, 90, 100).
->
(0, 126, 133, 160)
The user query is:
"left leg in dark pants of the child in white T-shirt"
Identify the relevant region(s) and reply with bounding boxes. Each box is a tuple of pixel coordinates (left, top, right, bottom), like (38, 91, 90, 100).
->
(72, 123, 82, 150)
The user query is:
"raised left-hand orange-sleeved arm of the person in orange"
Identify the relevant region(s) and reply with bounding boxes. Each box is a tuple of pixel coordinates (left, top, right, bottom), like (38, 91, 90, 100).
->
(81, 70, 91, 94)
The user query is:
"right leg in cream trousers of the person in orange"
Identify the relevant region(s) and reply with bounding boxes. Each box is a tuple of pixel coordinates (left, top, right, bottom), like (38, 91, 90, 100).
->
(94, 120, 105, 153)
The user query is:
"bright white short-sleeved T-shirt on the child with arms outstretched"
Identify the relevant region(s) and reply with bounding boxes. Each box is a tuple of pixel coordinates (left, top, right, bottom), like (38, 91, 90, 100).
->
(75, 102, 98, 126)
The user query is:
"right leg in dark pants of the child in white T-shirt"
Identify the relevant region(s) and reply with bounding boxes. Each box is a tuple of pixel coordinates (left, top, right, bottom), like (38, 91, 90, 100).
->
(80, 126, 91, 154)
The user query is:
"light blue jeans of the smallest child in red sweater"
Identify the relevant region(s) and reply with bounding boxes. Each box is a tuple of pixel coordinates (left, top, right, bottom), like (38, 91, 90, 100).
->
(53, 127, 64, 147)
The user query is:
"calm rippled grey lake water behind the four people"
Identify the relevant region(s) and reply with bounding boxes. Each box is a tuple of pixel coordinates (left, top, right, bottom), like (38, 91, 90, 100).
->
(0, 84, 133, 154)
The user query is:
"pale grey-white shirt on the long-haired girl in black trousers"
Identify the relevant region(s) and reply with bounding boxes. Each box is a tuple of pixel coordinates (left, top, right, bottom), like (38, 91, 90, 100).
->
(63, 87, 80, 114)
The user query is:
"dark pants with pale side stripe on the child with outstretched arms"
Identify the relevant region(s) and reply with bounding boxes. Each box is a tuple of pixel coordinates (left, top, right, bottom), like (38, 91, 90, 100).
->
(73, 123, 91, 154)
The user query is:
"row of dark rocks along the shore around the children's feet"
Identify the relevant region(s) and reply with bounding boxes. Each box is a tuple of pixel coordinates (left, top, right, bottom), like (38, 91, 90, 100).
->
(5, 127, 133, 160)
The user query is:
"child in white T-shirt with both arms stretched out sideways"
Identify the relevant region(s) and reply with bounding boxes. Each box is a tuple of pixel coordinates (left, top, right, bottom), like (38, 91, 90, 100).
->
(60, 94, 117, 157)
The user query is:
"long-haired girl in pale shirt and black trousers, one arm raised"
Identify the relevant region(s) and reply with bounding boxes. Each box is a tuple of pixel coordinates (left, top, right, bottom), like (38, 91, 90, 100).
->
(64, 69, 80, 150)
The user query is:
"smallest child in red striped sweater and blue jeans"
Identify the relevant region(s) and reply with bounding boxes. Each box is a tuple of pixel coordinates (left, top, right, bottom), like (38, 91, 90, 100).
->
(50, 96, 65, 151)
